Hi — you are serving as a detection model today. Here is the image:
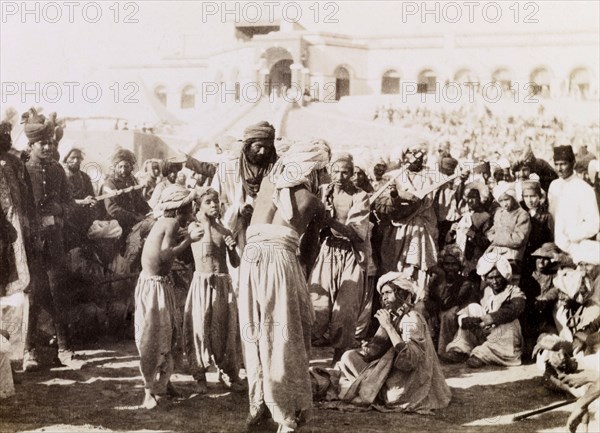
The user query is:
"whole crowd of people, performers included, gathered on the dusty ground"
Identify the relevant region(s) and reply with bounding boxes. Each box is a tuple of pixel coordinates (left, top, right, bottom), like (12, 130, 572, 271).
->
(0, 109, 600, 431)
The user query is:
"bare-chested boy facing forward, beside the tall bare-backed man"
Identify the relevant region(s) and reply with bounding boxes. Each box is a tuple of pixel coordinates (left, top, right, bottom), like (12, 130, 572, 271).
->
(183, 187, 244, 394)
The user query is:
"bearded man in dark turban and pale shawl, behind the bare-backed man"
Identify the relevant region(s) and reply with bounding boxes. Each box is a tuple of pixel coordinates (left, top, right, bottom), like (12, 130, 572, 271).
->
(211, 121, 277, 291)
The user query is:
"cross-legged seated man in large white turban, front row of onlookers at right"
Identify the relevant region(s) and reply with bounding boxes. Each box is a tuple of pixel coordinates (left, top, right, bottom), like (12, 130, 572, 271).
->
(443, 256, 525, 368)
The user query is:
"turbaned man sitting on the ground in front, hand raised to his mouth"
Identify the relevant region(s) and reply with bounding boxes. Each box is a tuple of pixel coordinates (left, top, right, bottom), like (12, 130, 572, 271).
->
(338, 272, 451, 412)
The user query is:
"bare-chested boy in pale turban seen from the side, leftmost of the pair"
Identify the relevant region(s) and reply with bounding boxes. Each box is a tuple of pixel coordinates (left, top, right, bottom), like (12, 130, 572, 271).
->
(135, 185, 201, 409)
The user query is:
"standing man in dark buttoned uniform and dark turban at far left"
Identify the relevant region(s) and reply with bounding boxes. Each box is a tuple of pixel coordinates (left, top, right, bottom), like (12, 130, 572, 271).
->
(23, 123, 81, 371)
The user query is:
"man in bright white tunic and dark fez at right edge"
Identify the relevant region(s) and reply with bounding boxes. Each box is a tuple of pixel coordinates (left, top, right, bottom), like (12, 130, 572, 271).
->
(548, 146, 600, 261)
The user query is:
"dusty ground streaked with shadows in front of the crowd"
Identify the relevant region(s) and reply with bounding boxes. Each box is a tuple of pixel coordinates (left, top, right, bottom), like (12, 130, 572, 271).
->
(0, 341, 580, 433)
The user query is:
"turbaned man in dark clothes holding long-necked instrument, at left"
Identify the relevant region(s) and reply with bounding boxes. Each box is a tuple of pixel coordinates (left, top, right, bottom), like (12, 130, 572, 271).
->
(101, 149, 151, 244)
